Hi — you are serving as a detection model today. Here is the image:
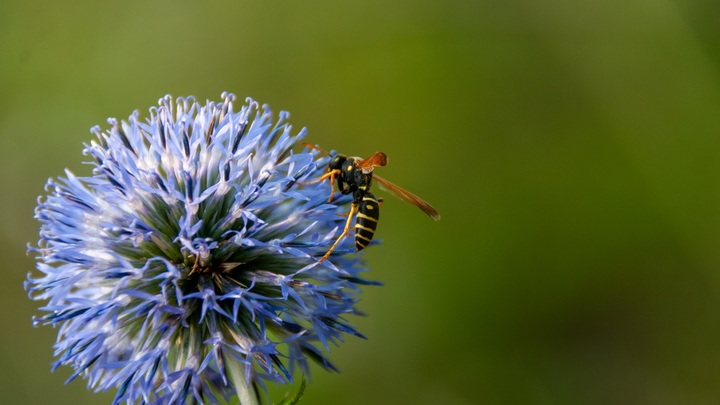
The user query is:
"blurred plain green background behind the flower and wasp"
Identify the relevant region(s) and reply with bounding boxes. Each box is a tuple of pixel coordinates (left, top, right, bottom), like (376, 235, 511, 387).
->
(0, 0, 720, 404)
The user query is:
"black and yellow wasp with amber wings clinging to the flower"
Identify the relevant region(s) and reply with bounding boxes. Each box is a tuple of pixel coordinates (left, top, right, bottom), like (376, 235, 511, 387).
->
(302, 143, 440, 262)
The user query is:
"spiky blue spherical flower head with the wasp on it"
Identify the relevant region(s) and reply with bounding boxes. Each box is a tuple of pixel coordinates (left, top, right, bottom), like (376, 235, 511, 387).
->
(26, 94, 380, 403)
